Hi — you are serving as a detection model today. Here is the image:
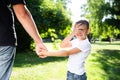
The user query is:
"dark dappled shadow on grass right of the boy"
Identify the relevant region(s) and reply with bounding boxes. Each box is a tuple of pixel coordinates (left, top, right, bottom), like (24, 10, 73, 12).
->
(94, 49, 120, 80)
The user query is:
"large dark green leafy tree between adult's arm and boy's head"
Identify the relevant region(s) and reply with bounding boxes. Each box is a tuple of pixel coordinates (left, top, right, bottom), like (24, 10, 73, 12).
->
(26, 0, 71, 38)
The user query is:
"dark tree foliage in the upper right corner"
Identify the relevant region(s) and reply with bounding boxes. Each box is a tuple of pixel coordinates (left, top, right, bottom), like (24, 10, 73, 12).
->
(104, 0, 120, 29)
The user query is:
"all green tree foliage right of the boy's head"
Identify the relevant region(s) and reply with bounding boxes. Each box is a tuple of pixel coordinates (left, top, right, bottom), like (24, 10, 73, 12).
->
(86, 0, 120, 38)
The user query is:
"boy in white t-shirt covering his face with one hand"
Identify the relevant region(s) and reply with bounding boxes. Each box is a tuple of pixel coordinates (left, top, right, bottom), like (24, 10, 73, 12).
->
(39, 20, 91, 80)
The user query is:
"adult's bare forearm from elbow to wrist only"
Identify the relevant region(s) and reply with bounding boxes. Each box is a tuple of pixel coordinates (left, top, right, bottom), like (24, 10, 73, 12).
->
(20, 12, 42, 43)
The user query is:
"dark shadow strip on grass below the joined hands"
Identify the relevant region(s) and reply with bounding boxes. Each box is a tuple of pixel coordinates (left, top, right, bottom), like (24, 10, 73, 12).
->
(13, 52, 67, 67)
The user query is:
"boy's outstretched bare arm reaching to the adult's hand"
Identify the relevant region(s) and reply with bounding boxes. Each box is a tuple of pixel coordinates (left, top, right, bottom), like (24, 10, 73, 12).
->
(39, 48, 81, 57)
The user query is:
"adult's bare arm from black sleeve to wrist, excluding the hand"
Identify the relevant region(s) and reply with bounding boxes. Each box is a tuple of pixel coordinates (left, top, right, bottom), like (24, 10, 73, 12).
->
(14, 5, 42, 43)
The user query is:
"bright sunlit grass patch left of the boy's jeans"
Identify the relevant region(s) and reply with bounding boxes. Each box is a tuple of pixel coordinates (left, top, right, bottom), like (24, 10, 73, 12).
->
(11, 57, 67, 80)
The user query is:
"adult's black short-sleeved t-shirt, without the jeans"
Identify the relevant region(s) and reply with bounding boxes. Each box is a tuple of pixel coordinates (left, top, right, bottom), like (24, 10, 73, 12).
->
(0, 0, 25, 46)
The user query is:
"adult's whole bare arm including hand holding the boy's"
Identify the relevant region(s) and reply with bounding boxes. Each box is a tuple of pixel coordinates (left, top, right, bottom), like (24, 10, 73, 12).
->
(13, 4, 47, 54)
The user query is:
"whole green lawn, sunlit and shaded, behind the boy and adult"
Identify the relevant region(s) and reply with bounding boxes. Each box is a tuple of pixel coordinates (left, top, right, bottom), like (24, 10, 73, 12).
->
(11, 42, 120, 80)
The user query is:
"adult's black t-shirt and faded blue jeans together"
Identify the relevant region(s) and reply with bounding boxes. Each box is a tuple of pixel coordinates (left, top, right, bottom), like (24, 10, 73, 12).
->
(0, 0, 25, 80)
